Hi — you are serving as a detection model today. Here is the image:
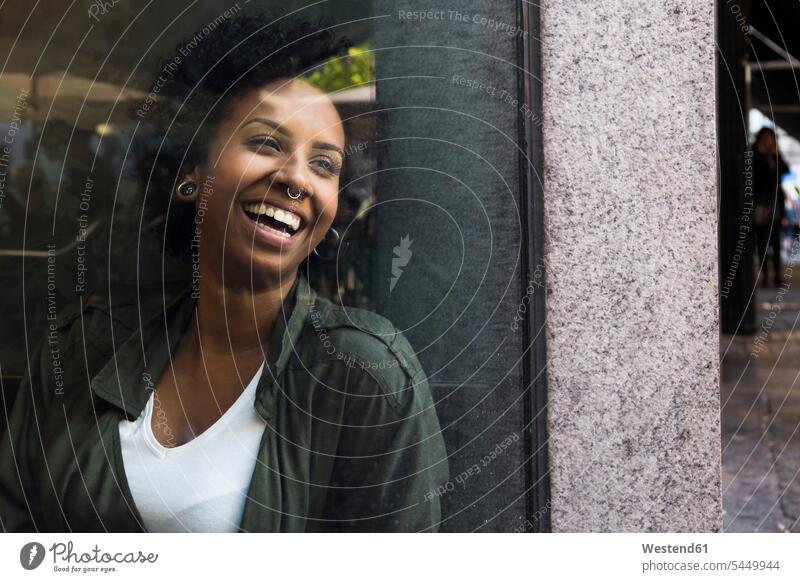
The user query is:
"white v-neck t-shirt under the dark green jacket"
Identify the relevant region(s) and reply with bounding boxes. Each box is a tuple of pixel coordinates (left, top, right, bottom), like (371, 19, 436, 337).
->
(119, 364, 266, 532)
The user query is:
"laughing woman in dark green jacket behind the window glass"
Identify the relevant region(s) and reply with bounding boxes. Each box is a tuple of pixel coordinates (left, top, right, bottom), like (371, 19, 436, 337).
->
(0, 17, 448, 532)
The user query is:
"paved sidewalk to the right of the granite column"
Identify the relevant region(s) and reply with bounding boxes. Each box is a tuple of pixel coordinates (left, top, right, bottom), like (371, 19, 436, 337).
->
(721, 286, 800, 532)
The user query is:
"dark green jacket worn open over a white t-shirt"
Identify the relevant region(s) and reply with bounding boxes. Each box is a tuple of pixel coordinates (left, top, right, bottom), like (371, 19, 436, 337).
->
(0, 276, 448, 532)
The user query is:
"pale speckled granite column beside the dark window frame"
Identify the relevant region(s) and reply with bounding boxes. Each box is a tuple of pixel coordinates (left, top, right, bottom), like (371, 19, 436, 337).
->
(542, 0, 722, 531)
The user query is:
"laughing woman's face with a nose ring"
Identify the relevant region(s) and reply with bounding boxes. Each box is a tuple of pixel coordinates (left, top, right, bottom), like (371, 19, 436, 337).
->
(196, 80, 344, 285)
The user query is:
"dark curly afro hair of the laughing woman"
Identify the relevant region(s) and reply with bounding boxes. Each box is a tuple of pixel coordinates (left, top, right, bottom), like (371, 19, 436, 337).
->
(132, 14, 350, 258)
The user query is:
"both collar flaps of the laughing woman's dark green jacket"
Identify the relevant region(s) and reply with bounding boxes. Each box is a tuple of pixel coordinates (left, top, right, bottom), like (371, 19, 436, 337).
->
(90, 273, 316, 420)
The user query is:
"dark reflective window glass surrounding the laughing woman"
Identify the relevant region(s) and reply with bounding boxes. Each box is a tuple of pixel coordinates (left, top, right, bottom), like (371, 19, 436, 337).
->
(0, 0, 543, 531)
